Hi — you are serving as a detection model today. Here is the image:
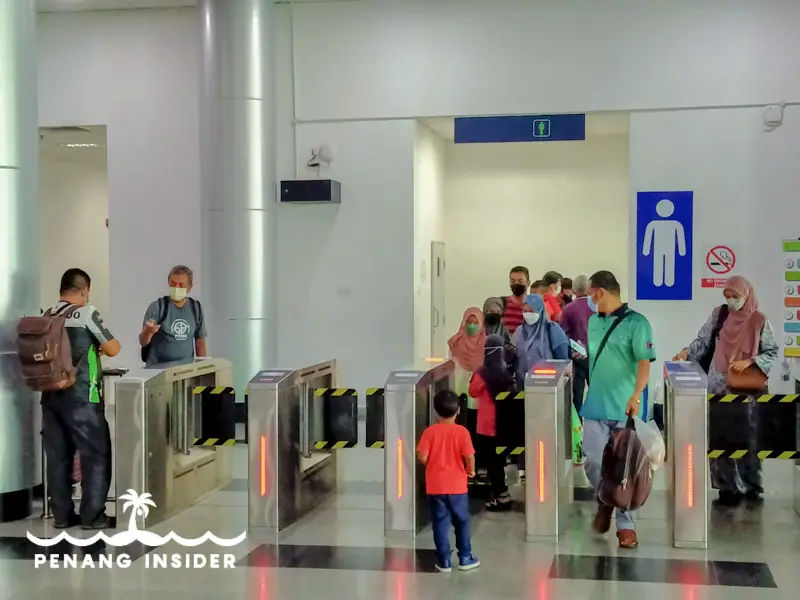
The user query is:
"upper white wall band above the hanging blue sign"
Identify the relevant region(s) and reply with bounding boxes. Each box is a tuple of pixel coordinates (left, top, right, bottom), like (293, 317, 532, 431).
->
(295, 0, 800, 120)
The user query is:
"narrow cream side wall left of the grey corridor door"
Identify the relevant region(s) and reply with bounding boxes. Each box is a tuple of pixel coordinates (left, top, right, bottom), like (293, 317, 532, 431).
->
(414, 123, 446, 359)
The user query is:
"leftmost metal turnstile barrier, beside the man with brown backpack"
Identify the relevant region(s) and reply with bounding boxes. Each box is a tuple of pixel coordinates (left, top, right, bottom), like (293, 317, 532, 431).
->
(114, 358, 233, 528)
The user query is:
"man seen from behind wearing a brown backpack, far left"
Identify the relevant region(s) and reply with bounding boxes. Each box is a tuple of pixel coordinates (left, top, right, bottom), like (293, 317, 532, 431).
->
(25, 269, 120, 529)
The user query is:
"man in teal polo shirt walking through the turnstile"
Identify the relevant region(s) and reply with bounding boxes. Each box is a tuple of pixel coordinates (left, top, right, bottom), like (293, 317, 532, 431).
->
(581, 271, 656, 548)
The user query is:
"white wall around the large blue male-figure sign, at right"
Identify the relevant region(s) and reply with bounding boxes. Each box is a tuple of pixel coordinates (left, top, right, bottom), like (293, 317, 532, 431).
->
(629, 106, 800, 392)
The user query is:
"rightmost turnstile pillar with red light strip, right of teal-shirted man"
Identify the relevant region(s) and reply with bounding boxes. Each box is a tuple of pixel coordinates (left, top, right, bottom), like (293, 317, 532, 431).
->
(664, 362, 709, 549)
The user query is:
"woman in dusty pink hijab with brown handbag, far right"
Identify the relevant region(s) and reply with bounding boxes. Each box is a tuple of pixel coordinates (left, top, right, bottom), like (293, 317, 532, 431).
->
(673, 275, 778, 505)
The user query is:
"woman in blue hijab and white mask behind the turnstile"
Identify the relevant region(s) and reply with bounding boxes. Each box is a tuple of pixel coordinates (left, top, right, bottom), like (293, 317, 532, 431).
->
(511, 294, 569, 385)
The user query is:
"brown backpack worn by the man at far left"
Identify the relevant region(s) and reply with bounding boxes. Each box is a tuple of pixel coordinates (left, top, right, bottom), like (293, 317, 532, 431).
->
(17, 304, 79, 392)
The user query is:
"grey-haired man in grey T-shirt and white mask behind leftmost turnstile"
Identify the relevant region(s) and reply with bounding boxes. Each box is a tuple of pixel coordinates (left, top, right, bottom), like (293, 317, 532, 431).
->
(139, 265, 206, 367)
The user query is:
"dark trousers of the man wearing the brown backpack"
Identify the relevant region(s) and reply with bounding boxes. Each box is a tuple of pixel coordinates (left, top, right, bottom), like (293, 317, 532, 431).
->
(42, 398, 111, 525)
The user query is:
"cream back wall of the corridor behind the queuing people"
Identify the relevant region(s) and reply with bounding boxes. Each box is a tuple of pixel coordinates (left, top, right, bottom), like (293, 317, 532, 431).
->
(444, 135, 630, 327)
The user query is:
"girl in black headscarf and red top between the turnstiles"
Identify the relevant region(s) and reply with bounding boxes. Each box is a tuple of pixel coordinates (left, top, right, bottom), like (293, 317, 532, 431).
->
(469, 335, 516, 511)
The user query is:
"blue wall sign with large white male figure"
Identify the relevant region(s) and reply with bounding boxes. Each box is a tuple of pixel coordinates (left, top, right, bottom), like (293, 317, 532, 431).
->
(636, 192, 694, 300)
